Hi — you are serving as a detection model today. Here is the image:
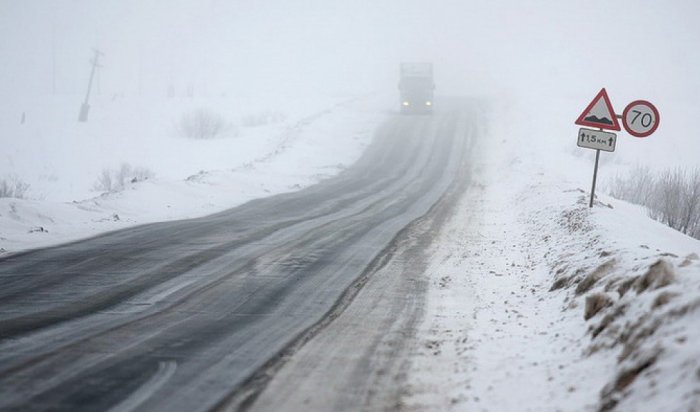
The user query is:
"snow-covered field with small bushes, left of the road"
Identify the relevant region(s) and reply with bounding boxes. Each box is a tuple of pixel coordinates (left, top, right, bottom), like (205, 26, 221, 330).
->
(0, 95, 387, 253)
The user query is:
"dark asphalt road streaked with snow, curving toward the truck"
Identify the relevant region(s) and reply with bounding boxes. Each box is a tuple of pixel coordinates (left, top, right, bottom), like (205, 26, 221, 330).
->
(0, 101, 476, 411)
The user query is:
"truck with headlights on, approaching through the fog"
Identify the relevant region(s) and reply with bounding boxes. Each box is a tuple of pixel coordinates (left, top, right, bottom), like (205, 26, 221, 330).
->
(399, 62, 435, 114)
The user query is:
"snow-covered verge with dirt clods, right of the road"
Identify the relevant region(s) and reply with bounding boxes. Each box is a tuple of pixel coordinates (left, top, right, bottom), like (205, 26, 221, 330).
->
(401, 100, 700, 411)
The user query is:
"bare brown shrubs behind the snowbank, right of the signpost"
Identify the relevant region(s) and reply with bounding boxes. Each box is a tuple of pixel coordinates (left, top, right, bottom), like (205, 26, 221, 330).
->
(609, 168, 700, 239)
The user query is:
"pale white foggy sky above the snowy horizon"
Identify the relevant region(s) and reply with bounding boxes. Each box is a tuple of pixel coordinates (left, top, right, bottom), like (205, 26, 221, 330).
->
(0, 0, 700, 100)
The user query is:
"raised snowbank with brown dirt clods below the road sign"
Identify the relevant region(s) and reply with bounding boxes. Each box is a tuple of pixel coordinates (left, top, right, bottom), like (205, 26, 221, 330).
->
(531, 190, 700, 410)
